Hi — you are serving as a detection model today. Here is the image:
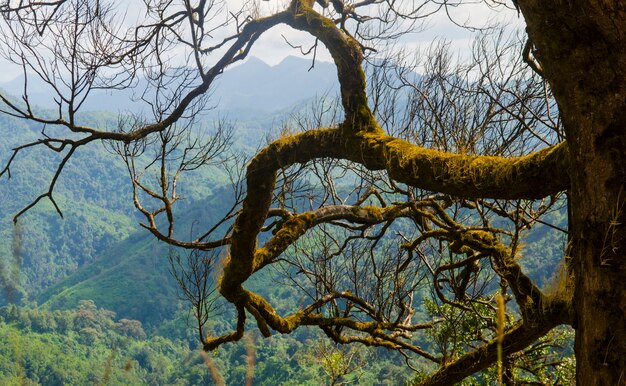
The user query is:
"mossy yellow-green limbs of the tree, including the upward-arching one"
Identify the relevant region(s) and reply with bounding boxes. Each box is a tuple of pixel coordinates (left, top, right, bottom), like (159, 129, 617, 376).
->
(205, 0, 570, 368)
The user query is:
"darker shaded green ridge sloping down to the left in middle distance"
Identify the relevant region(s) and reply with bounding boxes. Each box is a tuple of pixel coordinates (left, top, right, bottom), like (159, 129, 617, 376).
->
(36, 188, 238, 328)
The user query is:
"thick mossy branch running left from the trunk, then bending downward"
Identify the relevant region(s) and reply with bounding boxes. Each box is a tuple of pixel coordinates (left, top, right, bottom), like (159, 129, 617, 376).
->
(220, 129, 569, 300)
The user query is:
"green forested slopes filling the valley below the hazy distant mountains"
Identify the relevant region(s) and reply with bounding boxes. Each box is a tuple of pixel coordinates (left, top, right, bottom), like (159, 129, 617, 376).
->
(0, 92, 412, 385)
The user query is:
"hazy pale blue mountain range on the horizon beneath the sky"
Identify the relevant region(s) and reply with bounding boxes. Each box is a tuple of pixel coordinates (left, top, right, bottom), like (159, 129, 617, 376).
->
(0, 56, 339, 113)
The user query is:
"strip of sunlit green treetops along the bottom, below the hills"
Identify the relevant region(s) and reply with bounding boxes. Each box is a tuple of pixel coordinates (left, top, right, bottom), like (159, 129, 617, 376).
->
(0, 301, 411, 386)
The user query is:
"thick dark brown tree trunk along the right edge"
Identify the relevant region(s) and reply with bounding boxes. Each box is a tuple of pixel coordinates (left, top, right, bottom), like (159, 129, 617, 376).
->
(519, 0, 626, 386)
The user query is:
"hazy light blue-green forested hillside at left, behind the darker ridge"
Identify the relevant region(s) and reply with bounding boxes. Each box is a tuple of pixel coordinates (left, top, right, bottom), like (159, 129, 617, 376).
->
(0, 110, 137, 302)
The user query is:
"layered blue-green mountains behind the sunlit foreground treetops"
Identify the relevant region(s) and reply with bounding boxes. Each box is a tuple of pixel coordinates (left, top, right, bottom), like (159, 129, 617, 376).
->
(0, 57, 339, 326)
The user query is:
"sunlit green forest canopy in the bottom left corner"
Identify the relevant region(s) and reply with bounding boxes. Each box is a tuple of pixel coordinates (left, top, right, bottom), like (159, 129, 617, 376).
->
(0, 301, 230, 385)
